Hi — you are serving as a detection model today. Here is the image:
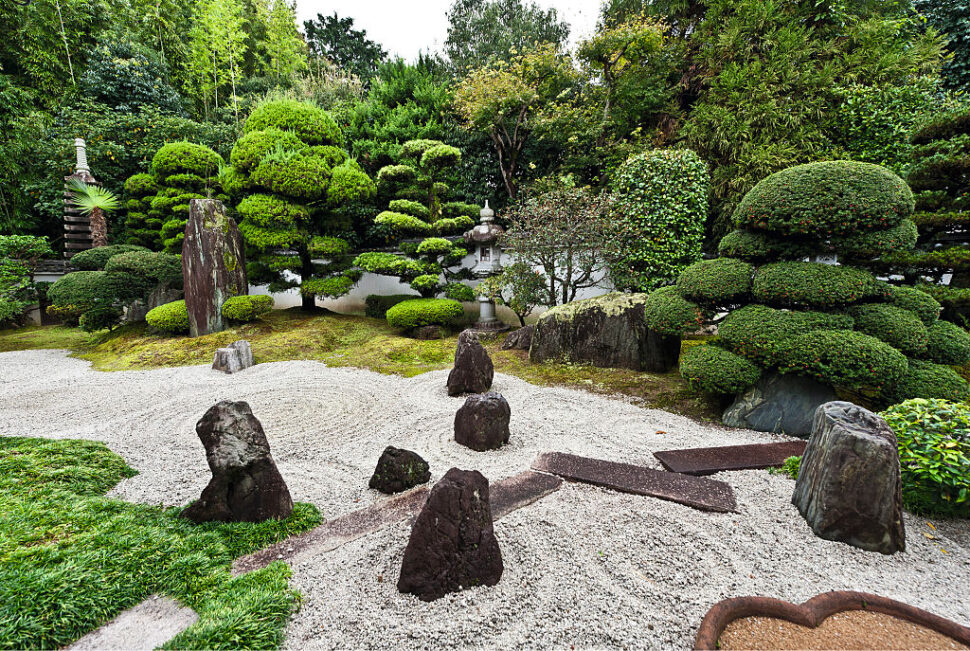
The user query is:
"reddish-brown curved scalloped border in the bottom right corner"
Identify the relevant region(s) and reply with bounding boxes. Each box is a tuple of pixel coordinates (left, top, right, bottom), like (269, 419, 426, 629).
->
(694, 591, 970, 651)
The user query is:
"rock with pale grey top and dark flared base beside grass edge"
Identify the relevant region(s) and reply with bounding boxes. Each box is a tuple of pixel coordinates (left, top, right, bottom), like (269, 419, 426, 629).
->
(182, 400, 293, 522)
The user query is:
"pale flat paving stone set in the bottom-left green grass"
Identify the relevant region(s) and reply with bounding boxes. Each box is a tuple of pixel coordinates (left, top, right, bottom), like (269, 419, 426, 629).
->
(67, 595, 199, 651)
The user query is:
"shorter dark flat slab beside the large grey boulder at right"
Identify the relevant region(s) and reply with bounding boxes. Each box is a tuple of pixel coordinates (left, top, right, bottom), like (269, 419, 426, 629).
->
(653, 441, 806, 475)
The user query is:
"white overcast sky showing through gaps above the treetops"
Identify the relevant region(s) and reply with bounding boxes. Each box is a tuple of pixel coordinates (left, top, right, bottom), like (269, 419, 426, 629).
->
(297, 0, 600, 60)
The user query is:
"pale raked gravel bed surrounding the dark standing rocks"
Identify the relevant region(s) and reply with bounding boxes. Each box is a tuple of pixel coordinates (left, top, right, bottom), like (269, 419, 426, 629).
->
(0, 351, 970, 649)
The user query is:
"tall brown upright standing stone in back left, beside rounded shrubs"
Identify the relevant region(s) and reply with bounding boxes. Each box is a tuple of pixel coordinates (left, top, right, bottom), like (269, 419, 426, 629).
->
(182, 199, 249, 337)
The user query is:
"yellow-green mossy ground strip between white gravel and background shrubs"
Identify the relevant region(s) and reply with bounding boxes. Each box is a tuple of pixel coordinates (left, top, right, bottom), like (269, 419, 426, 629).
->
(0, 309, 720, 421)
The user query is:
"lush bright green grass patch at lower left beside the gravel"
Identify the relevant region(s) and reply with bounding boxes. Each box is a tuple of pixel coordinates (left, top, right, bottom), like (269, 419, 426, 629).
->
(0, 438, 320, 649)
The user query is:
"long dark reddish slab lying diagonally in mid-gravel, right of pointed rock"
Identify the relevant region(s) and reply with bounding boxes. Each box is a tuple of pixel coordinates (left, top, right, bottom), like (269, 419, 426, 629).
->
(532, 452, 738, 513)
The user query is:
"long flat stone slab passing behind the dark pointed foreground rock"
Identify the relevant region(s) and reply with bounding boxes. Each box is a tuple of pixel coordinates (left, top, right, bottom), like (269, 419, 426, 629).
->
(232, 470, 562, 575)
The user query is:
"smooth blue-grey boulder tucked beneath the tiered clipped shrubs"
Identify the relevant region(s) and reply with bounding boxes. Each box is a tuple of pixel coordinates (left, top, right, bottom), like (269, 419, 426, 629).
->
(721, 373, 836, 437)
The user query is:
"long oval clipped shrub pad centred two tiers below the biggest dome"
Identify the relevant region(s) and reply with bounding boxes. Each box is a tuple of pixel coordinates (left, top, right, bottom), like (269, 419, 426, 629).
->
(751, 262, 890, 309)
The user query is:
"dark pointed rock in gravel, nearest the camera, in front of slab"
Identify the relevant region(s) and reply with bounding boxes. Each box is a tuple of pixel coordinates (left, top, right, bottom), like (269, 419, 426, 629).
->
(397, 468, 504, 601)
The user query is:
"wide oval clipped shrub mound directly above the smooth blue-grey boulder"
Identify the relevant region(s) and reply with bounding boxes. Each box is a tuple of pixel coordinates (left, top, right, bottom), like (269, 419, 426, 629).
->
(777, 330, 908, 389)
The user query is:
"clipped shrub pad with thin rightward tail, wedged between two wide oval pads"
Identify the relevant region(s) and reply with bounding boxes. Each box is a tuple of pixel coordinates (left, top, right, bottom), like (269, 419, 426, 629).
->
(718, 305, 854, 366)
